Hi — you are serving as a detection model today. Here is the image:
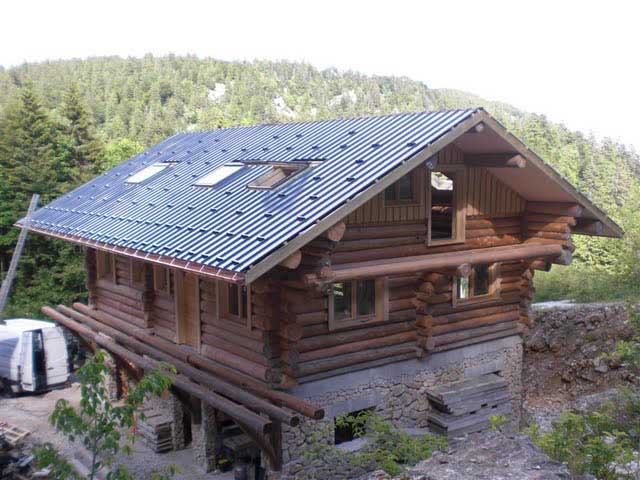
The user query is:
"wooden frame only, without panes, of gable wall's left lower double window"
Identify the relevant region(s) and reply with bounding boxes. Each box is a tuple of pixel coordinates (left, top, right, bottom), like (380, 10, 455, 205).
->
(328, 277, 389, 330)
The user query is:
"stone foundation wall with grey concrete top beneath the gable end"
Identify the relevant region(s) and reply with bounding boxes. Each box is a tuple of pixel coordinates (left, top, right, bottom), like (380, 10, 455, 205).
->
(269, 336, 522, 480)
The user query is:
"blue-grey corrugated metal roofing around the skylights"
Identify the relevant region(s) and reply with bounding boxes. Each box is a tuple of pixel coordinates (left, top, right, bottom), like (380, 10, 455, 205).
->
(20, 109, 477, 272)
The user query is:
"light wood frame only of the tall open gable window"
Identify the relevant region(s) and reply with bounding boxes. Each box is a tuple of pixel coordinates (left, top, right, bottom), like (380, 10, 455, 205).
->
(426, 165, 467, 247)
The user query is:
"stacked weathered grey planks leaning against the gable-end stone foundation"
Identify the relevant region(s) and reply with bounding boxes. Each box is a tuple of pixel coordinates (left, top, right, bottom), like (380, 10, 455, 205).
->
(427, 373, 511, 438)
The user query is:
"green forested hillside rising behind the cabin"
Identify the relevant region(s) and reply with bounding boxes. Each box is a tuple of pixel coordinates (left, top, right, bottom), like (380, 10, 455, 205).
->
(0, 55, 640, 315)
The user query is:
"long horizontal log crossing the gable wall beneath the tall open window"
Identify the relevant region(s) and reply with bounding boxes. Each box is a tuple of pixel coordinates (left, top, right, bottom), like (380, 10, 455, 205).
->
(307, 243, 563, 283)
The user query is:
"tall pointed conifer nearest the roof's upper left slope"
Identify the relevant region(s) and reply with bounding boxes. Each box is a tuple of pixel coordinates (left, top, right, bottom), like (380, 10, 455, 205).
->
(62, 83, 104, 176)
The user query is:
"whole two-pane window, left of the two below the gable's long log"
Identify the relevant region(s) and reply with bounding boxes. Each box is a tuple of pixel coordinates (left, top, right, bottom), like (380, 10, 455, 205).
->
(329, 278, 389, 329)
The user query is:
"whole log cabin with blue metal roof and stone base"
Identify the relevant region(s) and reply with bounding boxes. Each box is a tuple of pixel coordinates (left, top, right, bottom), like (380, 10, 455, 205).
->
(18, 108, 623, 479)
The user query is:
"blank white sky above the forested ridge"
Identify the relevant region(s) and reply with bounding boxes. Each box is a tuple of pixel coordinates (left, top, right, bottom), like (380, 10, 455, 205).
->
(0, 0, 640, 151)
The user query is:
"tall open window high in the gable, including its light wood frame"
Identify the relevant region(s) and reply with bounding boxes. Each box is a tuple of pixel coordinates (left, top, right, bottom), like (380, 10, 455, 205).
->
(428, 168, 465, 245)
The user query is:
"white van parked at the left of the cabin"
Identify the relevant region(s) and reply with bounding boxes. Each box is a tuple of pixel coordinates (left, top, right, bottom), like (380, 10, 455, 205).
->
(0, 318, 69, 392)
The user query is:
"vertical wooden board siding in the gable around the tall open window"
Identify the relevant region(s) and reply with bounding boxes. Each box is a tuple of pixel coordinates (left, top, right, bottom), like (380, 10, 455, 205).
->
(345, 145, 525, 225)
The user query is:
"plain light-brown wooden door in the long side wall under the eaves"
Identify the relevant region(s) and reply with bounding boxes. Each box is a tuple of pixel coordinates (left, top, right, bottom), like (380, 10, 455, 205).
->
(176, 272, 200, 349)
